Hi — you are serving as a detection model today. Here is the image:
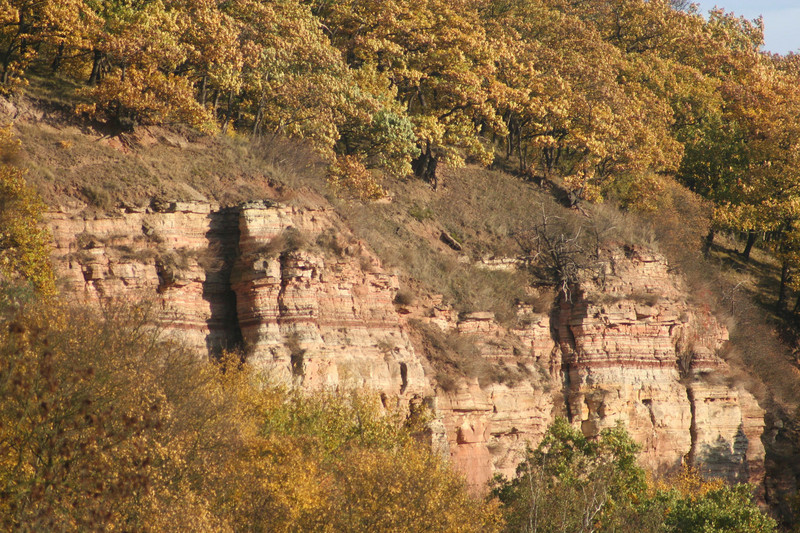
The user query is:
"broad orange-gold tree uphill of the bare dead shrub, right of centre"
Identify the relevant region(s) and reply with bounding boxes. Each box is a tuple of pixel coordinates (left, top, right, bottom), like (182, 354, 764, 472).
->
(484, 0, 680, 201)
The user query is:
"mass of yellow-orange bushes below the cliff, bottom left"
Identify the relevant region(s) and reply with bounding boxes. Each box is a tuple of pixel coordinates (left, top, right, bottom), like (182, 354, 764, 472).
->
(0, 285, 500, 532)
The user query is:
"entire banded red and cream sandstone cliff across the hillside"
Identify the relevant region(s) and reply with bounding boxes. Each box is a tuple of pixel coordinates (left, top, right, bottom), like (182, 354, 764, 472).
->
(49, 201, 764, 488)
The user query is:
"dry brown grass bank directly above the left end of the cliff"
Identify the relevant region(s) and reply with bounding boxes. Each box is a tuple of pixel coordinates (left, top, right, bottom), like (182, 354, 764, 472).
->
(16, 113, 324, 212)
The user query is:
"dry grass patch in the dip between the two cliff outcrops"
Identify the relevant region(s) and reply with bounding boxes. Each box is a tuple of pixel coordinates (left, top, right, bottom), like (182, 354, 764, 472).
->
(336, 167, 579, 323)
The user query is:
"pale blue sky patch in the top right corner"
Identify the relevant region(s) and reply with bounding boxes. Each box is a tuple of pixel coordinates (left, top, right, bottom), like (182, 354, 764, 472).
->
(694, 0, 800, 54)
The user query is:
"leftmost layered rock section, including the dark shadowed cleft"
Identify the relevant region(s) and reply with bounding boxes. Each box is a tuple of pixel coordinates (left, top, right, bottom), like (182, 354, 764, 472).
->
(48, 202, 238, 352)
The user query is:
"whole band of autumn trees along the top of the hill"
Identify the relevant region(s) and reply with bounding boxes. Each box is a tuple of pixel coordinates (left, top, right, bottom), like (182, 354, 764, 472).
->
(0, 0, 800, 300)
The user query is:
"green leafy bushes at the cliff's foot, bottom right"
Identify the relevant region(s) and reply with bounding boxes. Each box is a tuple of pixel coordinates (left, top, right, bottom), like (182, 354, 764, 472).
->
(494, 418, 776, 533)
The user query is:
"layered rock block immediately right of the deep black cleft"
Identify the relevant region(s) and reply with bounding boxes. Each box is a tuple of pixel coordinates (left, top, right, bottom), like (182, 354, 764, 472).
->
(232, 203, 426, 396)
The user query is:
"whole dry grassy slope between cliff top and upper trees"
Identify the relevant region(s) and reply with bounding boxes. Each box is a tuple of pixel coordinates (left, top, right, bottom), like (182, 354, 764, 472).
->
(9, 85, 800, 410)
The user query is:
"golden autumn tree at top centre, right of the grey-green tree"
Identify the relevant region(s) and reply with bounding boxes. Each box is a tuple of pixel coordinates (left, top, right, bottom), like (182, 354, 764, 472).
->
(311, 0, 502, 185)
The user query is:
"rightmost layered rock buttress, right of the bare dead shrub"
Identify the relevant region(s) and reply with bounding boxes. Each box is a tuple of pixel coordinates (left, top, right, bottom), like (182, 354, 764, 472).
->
(558, 249, 764, 482)
